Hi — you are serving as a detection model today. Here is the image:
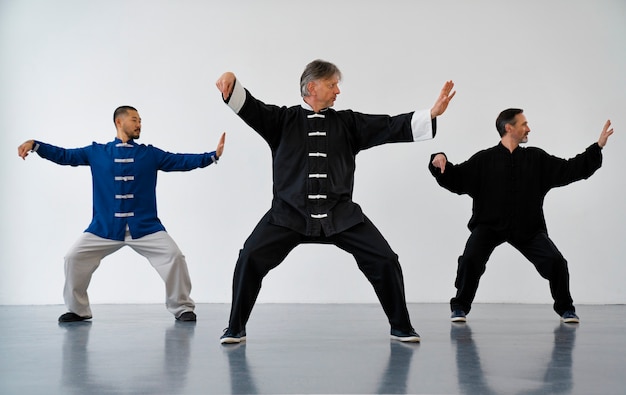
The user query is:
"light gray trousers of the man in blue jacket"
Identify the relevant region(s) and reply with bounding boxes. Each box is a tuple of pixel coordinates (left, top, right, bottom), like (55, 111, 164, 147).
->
(63, 231, 195, 317)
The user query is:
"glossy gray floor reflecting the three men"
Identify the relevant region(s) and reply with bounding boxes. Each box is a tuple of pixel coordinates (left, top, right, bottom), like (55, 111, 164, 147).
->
(0, 304, 626, 395)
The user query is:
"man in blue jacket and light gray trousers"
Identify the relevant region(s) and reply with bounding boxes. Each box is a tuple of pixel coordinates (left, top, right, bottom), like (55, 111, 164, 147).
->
(17, 106, 225, 322)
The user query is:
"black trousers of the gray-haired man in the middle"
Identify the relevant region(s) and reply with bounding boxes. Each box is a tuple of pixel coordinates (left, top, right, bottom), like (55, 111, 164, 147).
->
(228, 214, 413, 332)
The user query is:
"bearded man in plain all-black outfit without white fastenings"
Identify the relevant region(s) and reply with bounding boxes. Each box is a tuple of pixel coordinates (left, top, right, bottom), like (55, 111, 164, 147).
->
(429, 108, 613, 323)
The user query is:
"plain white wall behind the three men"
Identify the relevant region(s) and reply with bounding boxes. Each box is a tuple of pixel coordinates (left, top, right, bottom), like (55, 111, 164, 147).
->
(0, 0, 626, 304)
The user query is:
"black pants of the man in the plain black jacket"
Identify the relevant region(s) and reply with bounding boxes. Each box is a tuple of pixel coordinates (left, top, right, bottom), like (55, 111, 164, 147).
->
(450, 226, 575, 315)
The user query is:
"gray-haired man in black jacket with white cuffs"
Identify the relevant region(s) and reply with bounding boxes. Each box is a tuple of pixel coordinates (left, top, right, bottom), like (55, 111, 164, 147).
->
(216, 60, 456, 344)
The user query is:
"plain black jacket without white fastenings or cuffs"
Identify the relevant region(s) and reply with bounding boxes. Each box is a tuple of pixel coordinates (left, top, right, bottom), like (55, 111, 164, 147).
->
(429, 143, 602, 241)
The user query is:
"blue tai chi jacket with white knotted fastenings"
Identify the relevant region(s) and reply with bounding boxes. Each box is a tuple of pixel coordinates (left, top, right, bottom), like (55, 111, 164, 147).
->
(34, 138, 218, 241)
